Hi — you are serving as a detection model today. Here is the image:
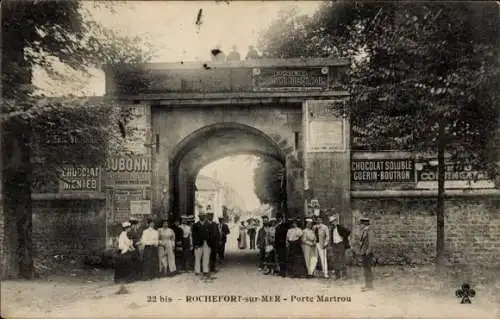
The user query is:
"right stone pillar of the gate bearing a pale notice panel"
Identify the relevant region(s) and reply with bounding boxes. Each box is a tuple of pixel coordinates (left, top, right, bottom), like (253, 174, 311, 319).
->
(303, 100, 351, 224)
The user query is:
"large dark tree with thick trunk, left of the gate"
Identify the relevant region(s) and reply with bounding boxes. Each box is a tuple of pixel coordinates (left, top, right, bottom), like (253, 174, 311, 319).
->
(0, 0, 151, 278)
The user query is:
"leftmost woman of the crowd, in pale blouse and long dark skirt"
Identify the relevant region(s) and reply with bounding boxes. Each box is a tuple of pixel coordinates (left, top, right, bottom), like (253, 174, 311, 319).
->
(114, 222, 137, 283)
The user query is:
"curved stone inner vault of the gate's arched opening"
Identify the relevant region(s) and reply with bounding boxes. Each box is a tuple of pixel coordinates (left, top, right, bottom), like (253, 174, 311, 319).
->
(169, 123, 286, 219)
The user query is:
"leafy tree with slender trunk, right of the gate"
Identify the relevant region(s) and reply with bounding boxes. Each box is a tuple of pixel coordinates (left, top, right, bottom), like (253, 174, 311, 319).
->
(262, 1, 500, 261)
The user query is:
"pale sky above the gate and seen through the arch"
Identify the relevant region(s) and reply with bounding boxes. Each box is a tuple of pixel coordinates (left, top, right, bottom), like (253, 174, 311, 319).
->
(34, 1, 320, 210)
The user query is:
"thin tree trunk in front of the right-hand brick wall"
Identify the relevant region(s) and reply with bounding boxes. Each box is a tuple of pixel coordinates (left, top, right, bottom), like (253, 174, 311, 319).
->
(436, 123, 446, 267)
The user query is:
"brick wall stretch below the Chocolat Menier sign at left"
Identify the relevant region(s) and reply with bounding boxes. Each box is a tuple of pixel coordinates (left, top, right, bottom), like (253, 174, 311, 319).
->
(33, 200, 106, 257)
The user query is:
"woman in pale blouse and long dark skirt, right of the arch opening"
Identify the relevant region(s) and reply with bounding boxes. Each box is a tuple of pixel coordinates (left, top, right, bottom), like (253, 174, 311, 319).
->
(286, 221, 307, 277)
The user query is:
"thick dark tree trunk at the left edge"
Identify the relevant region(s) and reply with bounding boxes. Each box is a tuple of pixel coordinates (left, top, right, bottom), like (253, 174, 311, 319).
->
(2, 127, 34, 279)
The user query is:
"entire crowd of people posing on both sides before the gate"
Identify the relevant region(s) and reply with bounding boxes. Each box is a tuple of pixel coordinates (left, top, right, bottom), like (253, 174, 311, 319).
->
(115, 212, 373, 290)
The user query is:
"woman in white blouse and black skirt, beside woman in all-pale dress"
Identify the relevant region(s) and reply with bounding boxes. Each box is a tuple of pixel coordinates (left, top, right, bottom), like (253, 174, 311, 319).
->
(140, 220, 160, 280)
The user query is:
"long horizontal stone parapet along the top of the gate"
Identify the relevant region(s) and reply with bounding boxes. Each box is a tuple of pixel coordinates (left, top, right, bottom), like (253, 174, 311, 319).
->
(103, 58, 350, 98)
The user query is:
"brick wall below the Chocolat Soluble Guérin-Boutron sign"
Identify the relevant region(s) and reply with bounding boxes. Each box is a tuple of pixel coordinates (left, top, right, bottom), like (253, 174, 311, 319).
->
(352, 198, 500, 267)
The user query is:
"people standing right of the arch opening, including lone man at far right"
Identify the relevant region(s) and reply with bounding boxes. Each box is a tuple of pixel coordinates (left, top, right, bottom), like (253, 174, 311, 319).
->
(252, 215, 373, 290)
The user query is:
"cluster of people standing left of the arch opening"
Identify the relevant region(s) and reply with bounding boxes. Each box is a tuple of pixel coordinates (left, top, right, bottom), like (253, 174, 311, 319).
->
(115, 213, 230, 283)
